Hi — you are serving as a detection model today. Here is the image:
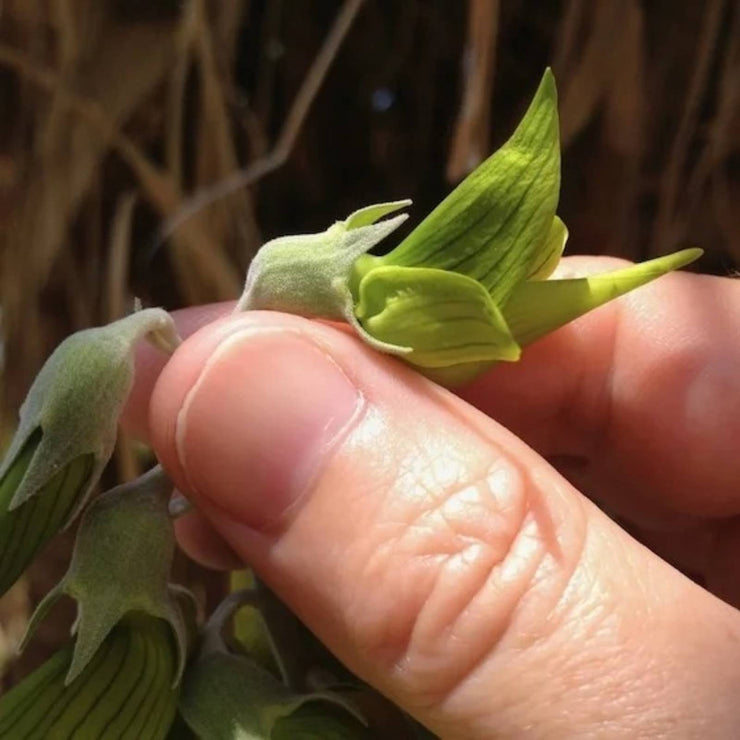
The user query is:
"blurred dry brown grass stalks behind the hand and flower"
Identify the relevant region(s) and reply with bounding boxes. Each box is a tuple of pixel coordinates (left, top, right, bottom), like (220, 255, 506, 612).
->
(0, 0, 740, 684)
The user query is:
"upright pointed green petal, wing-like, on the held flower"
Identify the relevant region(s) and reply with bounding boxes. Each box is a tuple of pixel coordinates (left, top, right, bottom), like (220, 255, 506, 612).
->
(382, 69, 560, 304)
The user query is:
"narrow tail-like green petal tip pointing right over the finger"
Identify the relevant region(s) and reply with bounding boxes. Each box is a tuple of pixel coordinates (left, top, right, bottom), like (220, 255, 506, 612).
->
(503, 249, 702, 346)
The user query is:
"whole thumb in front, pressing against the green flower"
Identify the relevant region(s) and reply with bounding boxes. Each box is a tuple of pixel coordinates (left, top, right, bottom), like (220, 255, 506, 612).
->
(151, 312, 740, 738)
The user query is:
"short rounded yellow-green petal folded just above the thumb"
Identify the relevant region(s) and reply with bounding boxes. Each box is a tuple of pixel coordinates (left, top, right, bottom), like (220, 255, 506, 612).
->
(356, 266, 519, 368)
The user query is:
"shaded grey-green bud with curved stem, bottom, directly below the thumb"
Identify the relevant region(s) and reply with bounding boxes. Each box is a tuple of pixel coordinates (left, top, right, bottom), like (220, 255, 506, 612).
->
(179, 592, 362, 740)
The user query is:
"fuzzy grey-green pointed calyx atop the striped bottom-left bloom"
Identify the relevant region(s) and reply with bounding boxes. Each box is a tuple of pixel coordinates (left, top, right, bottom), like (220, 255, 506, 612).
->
(21, 466, 192, 681)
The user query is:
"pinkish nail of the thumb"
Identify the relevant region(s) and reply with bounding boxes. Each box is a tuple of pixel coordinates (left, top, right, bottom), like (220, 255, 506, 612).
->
(176, 327, 361, 529)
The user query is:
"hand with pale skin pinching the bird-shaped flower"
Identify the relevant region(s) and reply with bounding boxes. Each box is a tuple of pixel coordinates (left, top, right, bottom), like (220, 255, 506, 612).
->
(126, 258, 740, 739)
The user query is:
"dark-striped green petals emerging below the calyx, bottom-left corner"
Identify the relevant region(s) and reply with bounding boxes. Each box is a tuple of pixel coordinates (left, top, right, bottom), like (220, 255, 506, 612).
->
(0, 613, 178, 740)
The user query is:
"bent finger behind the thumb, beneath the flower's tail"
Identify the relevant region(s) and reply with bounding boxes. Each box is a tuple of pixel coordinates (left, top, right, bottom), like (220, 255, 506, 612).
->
(461, 257, 740, 517)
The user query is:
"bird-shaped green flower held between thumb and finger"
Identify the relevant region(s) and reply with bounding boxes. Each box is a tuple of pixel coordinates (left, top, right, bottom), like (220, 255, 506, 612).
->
(239, 69, 701, 385)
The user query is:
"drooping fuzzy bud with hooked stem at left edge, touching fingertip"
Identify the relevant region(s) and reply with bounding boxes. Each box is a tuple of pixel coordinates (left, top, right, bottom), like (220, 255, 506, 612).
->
(0, 309, 177, 594)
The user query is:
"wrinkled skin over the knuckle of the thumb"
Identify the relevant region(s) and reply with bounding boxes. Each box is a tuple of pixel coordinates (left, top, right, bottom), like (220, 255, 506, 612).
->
(354, 450, 580, 704)
